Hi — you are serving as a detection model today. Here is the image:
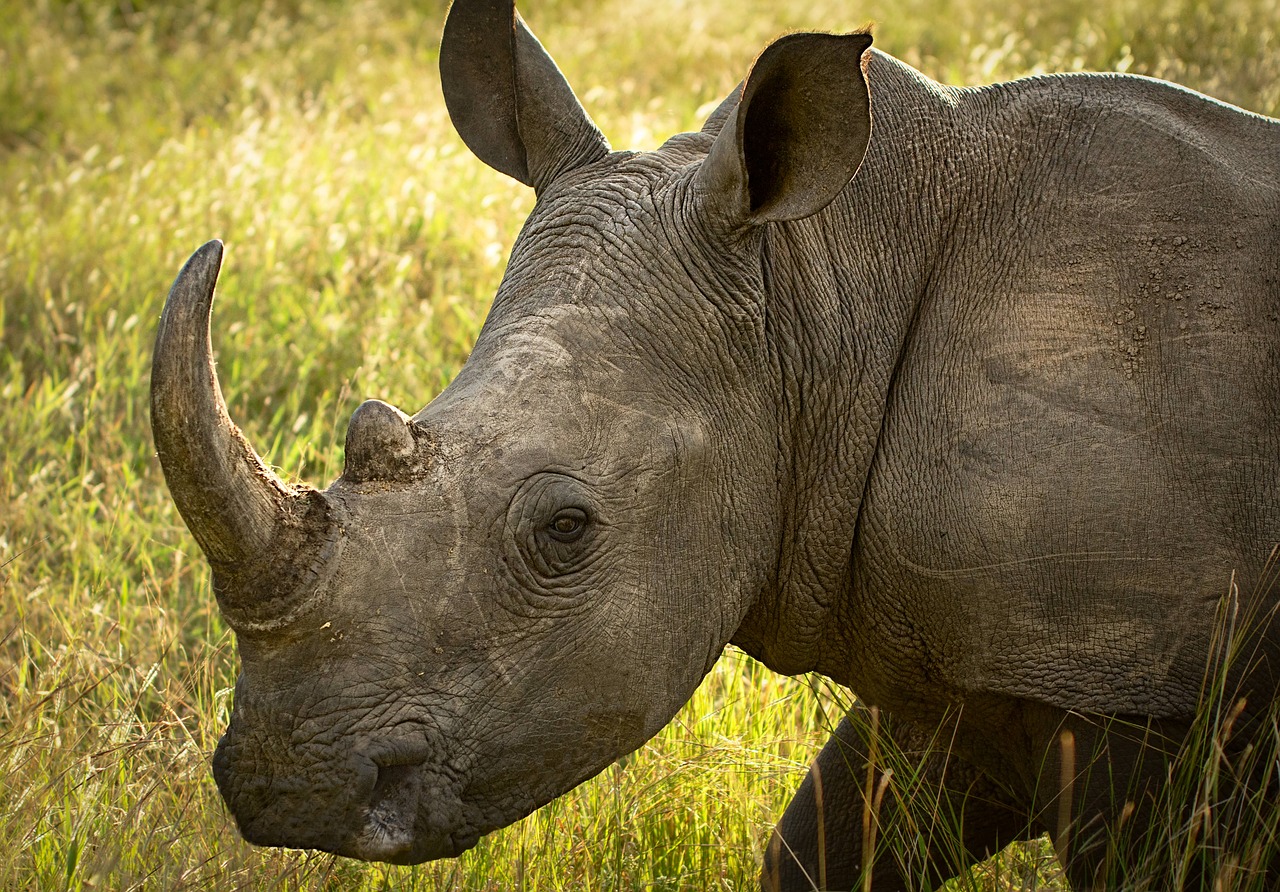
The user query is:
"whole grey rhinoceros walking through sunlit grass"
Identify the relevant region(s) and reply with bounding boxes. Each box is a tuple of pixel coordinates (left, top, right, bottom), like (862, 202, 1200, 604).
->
(151, 0, 1280, 889)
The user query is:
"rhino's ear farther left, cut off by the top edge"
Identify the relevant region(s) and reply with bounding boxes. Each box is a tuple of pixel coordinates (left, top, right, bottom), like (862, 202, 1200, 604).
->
(440, 0, 609, 192)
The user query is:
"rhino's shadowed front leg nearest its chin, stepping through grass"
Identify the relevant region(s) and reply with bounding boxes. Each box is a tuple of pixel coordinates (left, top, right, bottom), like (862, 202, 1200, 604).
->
(762, 708, 1033, 892)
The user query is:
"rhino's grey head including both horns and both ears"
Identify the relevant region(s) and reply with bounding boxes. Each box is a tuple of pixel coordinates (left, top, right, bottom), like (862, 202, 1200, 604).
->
(152, 0, 869, 863)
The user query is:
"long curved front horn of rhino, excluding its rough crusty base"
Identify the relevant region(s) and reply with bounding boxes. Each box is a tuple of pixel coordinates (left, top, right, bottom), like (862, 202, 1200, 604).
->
(151, 241, 305, 569)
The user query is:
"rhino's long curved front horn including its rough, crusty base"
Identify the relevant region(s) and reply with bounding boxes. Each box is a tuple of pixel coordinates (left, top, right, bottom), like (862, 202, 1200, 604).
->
(151, 241, 332, 625)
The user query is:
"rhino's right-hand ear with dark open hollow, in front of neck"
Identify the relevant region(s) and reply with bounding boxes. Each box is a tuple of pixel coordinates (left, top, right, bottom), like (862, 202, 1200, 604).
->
(696, 33, 872, 224)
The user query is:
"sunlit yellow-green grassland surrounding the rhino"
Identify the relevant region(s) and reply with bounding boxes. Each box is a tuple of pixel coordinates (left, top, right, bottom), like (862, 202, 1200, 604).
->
(0, 0, 1280, 889)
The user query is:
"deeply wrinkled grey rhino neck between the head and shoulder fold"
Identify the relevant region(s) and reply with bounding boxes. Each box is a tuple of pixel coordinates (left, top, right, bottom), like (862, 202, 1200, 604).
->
(733, 54, 954, 683)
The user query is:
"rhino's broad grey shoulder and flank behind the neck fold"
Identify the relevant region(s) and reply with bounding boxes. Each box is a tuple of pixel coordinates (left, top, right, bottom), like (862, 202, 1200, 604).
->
(850, 67, 1280, 717)
